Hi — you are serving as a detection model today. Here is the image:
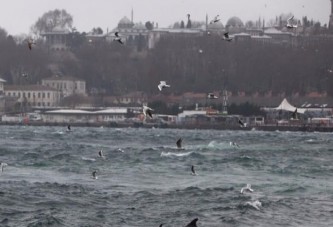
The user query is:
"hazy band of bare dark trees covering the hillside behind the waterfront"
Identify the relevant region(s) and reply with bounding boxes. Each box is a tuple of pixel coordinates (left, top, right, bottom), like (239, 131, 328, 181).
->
(0, 25, 333, 96)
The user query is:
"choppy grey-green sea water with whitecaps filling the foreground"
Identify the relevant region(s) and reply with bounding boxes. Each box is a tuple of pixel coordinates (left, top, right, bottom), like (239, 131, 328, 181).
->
(0, 126, 333, 227)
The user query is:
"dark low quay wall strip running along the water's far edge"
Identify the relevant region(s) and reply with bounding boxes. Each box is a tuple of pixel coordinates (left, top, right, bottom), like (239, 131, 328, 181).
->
(0, 122, 333, 132)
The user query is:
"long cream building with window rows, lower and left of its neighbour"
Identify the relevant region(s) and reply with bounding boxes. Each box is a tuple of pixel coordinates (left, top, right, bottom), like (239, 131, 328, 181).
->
(4, 85, 60, 107)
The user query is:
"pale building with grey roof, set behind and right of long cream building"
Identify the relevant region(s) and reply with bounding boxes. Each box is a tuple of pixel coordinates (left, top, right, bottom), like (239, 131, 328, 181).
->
(42, 76, 86, 98)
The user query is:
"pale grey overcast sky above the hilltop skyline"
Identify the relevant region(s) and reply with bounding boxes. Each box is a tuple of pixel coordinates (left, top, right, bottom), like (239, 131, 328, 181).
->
(0, 0, 331, 35)
